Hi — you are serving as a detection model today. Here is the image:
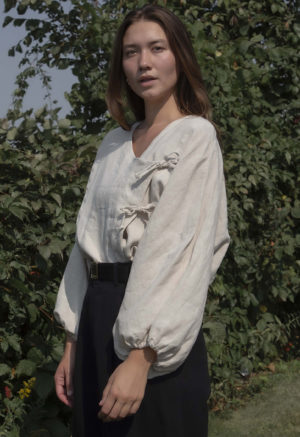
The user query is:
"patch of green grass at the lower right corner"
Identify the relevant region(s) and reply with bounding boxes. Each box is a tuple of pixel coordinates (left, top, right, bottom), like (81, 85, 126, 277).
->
(208, 360, 300, 437)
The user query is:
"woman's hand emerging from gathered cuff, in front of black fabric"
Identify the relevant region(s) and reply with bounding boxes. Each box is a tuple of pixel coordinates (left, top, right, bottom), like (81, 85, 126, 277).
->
(98, 348, 156, 422)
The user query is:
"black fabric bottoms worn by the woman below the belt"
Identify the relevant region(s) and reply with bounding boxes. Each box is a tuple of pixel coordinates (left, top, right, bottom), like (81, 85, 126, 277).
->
(72, 281, 210, 437)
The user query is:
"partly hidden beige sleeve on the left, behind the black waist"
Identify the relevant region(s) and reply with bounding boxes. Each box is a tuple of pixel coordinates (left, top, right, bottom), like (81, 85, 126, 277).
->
(54, 242, 88, 339)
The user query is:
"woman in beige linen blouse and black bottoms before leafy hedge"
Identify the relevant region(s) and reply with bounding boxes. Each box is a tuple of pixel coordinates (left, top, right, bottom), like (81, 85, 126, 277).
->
(55, 5, 229, 437)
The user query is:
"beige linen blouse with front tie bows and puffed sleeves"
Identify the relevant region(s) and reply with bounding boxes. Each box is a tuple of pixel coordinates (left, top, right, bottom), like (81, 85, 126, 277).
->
(54, 115, 229, 378)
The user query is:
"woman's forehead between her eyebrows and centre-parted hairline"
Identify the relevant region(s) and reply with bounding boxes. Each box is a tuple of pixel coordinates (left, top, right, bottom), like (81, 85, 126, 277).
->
(123, 20, 168, 45)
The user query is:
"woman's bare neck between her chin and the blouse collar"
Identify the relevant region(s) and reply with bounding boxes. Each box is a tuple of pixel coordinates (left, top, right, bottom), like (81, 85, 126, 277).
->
(143, 95, 183, 128)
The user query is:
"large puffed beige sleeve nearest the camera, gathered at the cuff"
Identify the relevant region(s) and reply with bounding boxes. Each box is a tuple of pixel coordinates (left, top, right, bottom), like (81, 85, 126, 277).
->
(113, 122, 229, 378)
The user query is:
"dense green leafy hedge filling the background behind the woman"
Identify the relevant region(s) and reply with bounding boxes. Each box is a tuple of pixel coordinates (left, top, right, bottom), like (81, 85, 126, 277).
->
(0, 0, 300, 437)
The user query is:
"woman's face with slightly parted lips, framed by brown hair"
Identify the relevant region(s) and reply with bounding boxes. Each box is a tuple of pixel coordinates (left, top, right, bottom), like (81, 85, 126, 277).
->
(123, 20, 178, 103)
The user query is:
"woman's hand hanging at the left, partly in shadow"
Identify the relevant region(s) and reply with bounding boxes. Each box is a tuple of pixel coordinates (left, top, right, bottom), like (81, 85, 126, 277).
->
(54, 339, 76, 408)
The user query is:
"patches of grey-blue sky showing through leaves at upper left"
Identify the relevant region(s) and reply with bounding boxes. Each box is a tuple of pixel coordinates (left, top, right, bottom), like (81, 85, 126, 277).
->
(0, 1, 75, 118)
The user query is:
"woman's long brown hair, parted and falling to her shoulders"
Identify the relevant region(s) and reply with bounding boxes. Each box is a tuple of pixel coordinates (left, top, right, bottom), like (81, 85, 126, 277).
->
(106, 5, 212, 130)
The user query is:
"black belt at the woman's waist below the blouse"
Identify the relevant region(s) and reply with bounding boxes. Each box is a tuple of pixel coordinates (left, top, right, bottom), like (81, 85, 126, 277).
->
(89, 262, 132, 284)
